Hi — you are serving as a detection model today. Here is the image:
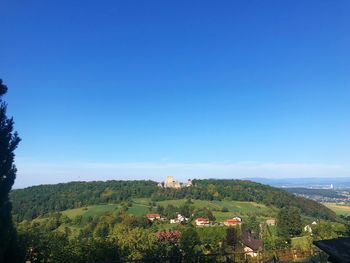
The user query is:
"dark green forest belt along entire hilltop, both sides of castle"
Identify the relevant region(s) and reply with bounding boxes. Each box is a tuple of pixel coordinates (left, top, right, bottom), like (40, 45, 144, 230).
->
(10, 180, 336, 221)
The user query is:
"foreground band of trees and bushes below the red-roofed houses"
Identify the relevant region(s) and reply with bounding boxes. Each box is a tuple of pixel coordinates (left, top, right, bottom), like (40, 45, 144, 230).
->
(17, 204, 347, 262)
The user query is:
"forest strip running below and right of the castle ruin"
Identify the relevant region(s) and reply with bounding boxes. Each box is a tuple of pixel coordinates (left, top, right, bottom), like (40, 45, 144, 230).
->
(153, 179, 336, 220)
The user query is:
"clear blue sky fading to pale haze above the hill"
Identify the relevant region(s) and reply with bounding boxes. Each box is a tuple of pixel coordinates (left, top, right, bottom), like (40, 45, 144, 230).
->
(0, 0, 350, 187)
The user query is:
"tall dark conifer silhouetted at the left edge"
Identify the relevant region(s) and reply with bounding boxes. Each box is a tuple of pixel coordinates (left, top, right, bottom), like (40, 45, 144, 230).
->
(0, 79, 20, 262)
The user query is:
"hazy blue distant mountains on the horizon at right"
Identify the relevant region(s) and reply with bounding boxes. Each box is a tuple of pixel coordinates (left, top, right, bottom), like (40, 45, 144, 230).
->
(247, 177, 350, 189)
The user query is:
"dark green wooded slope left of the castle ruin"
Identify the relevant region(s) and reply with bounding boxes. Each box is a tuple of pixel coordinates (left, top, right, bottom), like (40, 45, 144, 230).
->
(10, 181, 157, 221)
